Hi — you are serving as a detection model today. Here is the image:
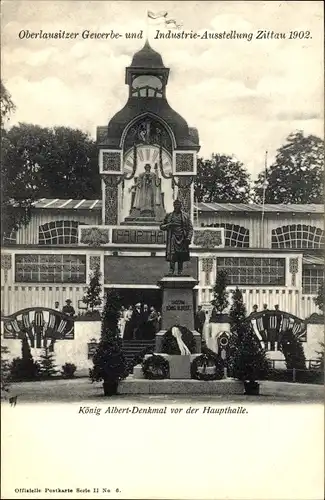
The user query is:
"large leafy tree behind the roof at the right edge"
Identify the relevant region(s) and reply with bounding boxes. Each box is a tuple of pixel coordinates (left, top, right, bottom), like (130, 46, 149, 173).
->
(254, 131, 324, 204)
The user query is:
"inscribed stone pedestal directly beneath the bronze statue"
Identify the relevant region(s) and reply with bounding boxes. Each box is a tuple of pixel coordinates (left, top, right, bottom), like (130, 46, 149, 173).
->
(155, 276, 201, 353)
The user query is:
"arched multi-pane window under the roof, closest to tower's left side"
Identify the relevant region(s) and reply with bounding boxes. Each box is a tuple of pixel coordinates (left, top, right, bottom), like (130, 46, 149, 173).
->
(38, 220, 79, 245)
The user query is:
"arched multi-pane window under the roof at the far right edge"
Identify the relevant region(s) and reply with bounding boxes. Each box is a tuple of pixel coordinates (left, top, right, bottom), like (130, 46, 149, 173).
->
(272, 224, 324, 248)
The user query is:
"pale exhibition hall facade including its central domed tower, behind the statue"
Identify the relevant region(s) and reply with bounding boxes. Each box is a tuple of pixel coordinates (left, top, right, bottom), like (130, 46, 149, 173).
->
(1, 42, 324, 319)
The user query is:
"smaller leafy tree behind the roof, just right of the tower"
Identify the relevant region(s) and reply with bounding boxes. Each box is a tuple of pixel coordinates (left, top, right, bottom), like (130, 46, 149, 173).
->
(194, 154, 250, 203)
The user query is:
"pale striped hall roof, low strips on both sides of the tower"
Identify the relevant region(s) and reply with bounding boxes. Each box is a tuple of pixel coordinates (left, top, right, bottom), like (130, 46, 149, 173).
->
(29, 198, 324, 214)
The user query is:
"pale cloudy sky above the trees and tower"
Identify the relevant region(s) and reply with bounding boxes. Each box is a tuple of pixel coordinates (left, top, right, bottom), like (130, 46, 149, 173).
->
(1, 0, 324, 178)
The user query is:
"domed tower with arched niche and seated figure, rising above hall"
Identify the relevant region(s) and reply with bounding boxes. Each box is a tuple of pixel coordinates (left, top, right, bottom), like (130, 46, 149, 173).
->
(97, 41, 200, 226)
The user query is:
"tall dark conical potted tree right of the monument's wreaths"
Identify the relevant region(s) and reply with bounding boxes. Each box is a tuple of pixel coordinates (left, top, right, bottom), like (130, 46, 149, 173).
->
(228, 288, 269, 395)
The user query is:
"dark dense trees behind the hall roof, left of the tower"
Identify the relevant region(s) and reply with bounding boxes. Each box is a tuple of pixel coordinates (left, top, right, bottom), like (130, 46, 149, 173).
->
(1, 123, 101, 238)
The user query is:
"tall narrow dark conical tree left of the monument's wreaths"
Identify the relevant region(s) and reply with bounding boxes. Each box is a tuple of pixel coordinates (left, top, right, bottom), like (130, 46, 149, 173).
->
(89, 290, 128, 396)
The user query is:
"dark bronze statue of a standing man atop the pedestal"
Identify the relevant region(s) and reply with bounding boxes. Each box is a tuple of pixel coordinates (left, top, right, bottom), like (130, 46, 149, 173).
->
(160, 200, 193, 275)
